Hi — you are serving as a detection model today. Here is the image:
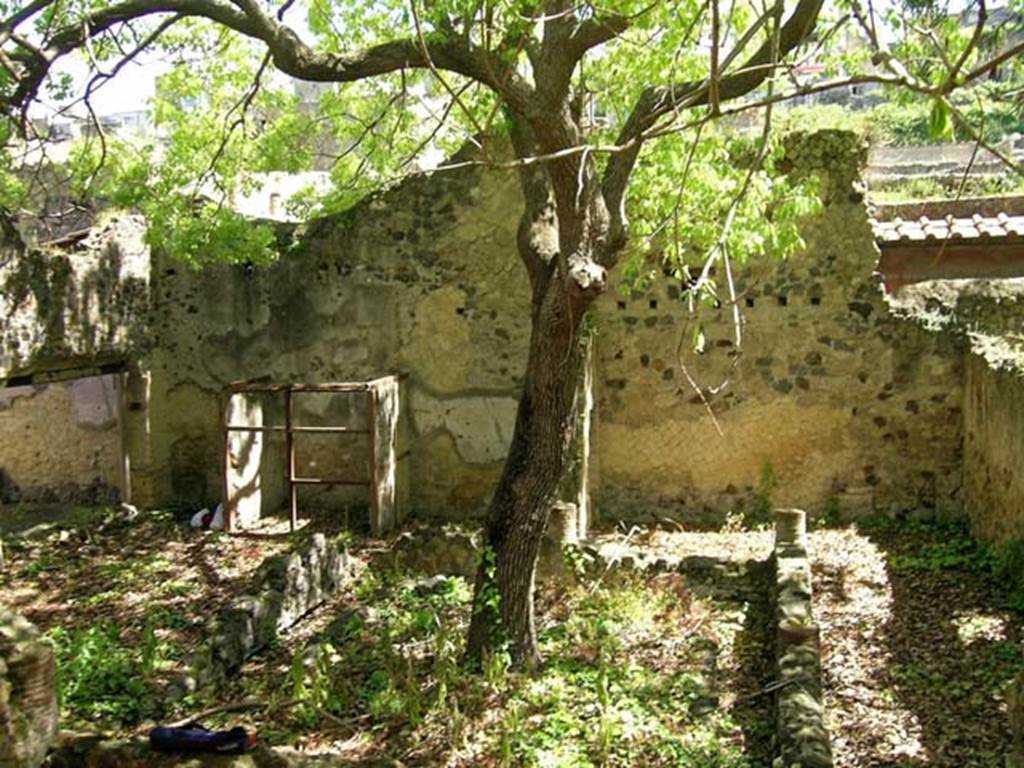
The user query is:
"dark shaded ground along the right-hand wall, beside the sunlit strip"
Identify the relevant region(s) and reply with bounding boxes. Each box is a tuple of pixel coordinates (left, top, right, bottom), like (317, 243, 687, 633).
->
(868, 526, 1024, 768)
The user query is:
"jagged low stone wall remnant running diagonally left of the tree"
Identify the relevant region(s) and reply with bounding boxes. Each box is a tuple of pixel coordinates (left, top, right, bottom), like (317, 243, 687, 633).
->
(191, 534, 352, 687)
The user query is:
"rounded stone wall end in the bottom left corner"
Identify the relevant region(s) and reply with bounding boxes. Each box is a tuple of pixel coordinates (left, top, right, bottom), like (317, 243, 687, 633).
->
(0, 606, 58, 768)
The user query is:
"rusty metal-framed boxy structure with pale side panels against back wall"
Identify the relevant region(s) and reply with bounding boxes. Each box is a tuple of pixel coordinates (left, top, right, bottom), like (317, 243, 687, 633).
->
(223, 376, 400, 535)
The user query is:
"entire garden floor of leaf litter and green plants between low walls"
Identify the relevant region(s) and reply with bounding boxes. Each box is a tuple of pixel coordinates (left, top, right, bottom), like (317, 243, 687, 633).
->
(0, 510, 1024, 768)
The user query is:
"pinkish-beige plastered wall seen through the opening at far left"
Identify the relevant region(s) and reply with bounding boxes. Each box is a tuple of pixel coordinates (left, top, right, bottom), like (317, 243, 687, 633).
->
(0, 376, 124, 503)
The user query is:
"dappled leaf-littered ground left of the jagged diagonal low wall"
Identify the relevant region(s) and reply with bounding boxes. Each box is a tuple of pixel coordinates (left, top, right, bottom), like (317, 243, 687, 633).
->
(0, 509, 299, 725)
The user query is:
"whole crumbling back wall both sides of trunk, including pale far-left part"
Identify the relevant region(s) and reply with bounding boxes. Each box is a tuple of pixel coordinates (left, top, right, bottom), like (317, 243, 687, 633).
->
(0, 132, 1009, 521)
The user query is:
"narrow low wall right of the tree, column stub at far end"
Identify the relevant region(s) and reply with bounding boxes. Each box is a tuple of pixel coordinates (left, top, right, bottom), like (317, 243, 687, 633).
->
(772, 509, 833, 768)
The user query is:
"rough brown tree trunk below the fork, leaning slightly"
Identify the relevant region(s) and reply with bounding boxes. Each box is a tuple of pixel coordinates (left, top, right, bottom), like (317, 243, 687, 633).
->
(466, 270, 589, 669)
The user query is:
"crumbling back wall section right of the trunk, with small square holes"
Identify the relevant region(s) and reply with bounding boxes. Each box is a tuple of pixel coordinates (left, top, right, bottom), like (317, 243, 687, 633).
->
(595, 132, 963, 522)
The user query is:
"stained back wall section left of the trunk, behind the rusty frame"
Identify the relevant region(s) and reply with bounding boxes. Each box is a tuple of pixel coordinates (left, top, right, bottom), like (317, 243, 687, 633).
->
(139, 164, 529, 519)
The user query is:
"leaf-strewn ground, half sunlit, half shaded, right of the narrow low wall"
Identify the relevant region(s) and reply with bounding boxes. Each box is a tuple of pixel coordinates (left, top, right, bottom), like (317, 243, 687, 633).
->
(809, 526, 1024, 768)
